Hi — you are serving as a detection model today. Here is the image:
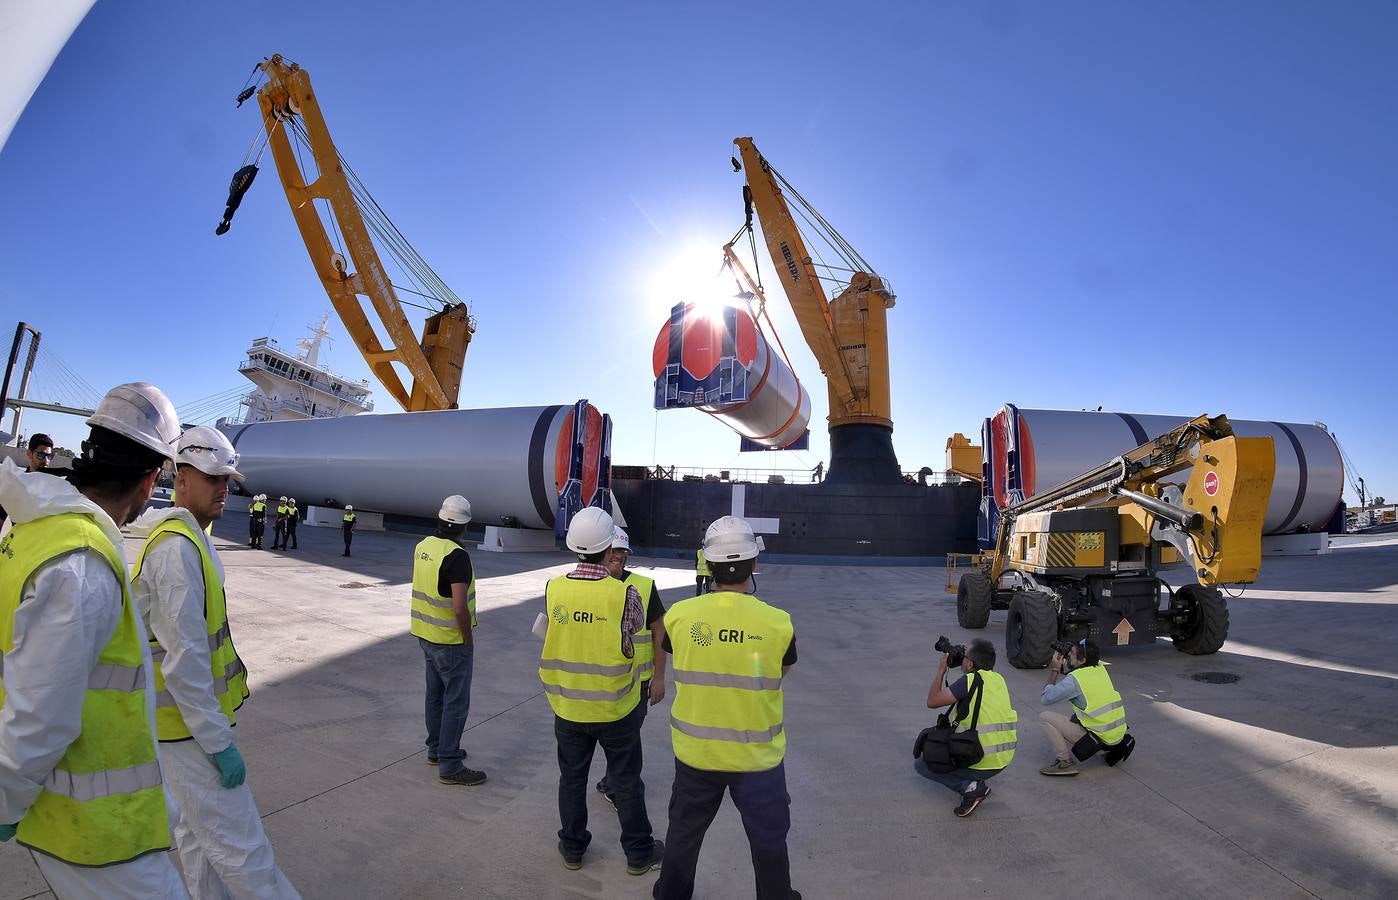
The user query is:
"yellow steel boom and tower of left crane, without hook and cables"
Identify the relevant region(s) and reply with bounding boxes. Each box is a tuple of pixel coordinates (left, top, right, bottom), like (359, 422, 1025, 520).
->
(257, 55, 475, 411)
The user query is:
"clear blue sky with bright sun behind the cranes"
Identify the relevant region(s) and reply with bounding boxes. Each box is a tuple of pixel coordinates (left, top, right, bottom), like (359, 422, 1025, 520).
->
(0, 0, 1398, 499)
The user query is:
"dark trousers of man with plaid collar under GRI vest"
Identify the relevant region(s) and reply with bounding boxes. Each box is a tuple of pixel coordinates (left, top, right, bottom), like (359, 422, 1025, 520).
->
(554, 703, 654, 865)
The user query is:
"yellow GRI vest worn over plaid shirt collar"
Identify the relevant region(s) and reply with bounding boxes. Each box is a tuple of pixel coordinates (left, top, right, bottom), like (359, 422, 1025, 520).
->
(538, 576, 640, 723)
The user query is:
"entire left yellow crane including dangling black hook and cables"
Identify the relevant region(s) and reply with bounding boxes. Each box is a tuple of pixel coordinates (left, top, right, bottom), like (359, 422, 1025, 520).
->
(217, 55, 475, 412)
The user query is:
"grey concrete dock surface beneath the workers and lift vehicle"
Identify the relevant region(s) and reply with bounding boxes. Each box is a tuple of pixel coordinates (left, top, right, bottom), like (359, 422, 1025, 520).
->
(0, 514, 1398, 900)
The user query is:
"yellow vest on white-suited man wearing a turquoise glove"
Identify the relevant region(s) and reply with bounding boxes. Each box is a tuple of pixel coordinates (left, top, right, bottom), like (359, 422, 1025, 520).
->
(131, 518, 247, 742)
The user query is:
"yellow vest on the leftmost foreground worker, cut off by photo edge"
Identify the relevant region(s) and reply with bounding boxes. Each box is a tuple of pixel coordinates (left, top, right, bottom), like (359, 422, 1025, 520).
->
(0, 513, 169, 866)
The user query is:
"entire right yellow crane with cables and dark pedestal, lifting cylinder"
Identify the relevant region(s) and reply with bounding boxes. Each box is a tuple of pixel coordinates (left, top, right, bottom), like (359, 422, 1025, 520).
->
(723, 137, 902, 484)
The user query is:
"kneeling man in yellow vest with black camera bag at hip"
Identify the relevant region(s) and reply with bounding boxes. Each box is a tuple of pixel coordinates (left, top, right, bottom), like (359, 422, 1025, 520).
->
(914, 637, 1019, 819)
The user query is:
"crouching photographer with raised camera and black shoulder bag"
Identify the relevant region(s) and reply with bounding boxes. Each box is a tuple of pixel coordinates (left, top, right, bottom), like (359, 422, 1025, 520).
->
(913, 636, 1018, 818)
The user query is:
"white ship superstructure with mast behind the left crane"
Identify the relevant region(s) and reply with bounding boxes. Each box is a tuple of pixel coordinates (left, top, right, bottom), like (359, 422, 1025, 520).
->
(238, 314, 373, 422)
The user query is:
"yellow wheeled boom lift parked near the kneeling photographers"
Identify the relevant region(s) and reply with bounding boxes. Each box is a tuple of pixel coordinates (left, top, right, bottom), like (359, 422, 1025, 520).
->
(956, 415, 1276, 668)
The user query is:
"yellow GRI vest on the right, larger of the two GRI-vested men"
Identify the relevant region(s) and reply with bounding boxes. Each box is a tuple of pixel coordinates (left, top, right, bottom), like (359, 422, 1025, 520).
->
(665, 591, 795, 771)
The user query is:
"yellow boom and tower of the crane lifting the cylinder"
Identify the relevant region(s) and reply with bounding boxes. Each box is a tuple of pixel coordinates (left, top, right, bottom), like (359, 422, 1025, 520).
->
(734, 137, 893, 427)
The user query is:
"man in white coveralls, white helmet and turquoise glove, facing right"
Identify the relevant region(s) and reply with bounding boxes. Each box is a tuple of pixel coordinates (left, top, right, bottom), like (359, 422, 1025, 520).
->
(131, 425, 301, 900)
